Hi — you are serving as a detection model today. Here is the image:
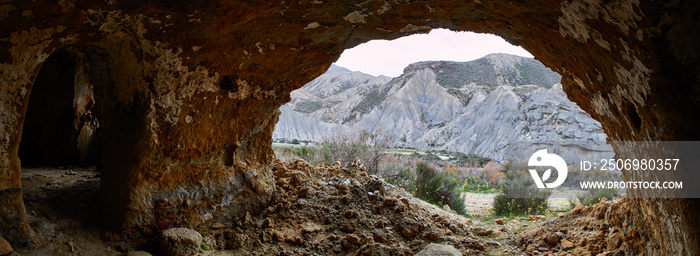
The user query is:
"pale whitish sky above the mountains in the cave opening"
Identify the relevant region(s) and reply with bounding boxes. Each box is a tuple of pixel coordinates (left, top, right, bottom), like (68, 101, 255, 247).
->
(335, 29, 532, 77)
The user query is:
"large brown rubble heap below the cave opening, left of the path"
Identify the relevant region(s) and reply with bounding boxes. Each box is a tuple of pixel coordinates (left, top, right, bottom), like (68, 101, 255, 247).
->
(204, 159, 485, 255)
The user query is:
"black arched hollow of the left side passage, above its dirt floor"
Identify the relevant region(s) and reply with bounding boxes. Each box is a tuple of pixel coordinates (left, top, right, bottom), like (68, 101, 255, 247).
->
(18, 50, 99, 167)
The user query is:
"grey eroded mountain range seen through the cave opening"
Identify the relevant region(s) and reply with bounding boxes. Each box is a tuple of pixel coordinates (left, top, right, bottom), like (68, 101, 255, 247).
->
(273, 54, 612, 160)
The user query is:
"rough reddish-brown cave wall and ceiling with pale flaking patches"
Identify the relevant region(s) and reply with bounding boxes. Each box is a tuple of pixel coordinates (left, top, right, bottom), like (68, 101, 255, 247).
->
(0, 0, 700, 255)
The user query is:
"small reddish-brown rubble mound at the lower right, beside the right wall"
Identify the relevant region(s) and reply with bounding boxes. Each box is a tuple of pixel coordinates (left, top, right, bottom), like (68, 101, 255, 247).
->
(516, 198, 662, 255)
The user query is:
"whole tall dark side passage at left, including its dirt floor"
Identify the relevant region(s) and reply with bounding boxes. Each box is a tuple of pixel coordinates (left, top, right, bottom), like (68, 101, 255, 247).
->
(18, 49, 101, 233)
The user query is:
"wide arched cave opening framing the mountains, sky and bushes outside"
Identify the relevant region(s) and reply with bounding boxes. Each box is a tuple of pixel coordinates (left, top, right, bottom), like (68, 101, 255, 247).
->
(273, 29, 621, 215)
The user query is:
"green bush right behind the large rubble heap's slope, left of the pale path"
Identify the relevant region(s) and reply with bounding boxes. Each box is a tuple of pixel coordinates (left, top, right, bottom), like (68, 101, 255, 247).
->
(414, 162, 465, 215)
